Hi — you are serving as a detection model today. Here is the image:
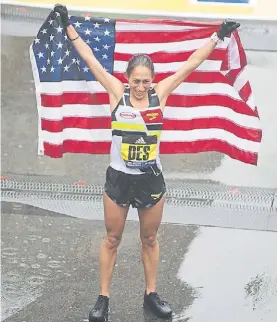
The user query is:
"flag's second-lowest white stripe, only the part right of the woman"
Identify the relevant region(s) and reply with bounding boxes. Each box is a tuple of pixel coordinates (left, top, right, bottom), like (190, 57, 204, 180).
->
(164, 106, 261, 129)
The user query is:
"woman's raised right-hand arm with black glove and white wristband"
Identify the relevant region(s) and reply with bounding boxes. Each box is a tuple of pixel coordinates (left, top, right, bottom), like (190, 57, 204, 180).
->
(155, 21, 240, 107)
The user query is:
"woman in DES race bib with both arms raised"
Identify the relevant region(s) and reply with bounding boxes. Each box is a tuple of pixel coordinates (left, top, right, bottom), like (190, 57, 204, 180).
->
(54, 5, 239, 322)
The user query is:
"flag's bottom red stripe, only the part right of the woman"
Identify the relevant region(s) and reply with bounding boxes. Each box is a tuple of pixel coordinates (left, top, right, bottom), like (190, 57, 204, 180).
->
(160, 139, 258, 165)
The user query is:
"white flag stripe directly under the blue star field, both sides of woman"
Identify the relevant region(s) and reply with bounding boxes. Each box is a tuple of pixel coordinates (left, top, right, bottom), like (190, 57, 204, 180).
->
(40, 81, 242, 101)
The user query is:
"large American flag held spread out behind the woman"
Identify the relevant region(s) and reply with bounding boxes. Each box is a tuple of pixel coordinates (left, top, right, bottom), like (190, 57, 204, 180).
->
(30, 11, 262, 165)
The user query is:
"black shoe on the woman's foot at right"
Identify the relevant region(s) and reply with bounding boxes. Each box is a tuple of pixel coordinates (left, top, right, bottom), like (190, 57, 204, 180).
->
(143, 292, 172, 318)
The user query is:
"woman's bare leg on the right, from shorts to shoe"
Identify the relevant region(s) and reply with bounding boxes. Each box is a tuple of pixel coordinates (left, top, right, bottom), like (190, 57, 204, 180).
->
(139, 198, 165, 294)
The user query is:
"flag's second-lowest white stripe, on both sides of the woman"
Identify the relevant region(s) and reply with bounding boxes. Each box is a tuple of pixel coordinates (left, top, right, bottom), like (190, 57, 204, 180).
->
(40, 104, 261, 129)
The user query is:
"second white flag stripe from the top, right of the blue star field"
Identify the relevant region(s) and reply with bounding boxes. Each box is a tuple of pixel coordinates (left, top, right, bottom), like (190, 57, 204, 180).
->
(115, 38, 230, 54)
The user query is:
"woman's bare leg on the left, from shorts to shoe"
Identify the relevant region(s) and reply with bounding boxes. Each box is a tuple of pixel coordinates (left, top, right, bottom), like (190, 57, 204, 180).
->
(100, 193, 129, 297)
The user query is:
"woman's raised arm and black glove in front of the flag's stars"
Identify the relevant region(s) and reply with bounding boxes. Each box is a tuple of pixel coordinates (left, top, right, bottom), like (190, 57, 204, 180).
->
(54, 5, 124, 105)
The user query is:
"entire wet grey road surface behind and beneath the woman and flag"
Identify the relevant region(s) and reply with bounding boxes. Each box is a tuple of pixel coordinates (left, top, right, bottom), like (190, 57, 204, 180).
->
(1, 4, 277, 322)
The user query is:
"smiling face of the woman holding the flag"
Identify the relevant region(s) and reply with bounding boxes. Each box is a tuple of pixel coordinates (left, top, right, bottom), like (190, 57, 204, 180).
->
(128, 66, 153, 100)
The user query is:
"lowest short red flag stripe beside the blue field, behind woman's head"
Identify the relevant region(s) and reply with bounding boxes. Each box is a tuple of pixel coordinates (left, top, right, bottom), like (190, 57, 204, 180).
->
(113, 71, 229, 84)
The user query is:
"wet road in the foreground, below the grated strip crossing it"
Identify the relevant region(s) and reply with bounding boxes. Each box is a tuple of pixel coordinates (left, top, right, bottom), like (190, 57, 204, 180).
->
(2, 203, 277, 322)
